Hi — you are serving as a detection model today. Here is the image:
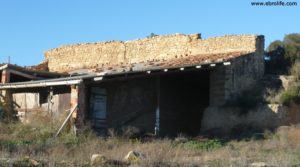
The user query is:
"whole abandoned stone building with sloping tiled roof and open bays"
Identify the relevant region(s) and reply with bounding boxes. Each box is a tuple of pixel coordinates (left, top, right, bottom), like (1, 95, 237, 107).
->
(0, 34, 264, 135)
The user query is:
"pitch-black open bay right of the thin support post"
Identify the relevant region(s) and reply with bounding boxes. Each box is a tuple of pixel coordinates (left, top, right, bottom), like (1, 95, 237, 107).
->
(159, 71, 209, 136)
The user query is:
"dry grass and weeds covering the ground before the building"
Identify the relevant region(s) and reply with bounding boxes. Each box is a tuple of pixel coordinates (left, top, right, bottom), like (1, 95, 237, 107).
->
(0, 111, 300, 167)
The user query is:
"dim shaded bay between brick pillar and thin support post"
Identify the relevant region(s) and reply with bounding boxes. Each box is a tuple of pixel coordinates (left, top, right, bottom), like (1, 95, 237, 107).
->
(88, 77, 156, 134)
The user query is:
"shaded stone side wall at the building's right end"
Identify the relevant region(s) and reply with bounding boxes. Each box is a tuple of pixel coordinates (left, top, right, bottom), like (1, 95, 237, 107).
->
(210, 37, 265, 106)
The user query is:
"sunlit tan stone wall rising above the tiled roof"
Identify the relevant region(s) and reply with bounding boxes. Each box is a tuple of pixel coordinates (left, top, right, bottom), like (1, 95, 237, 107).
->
(45, 34, 258, 72)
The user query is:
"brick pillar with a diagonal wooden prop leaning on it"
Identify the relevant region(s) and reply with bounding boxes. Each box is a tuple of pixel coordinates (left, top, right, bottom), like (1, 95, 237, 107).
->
(71, 83, 87, 126)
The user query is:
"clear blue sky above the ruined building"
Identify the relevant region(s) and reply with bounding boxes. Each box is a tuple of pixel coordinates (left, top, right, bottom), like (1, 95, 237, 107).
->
(0, 0, 300, 65)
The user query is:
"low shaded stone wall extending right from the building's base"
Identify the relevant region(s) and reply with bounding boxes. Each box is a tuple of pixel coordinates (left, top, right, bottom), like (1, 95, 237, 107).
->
(201, 104, 292, 134)
